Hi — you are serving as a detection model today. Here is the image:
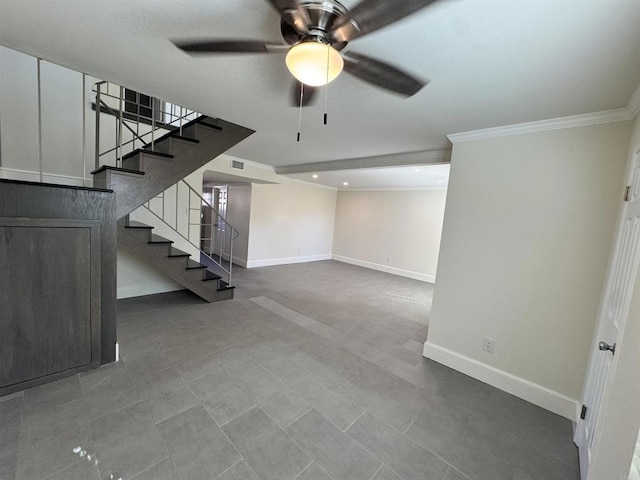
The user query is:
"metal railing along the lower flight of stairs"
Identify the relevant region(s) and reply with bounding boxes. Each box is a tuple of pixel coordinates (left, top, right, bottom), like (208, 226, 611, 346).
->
(142, 179, 240, 285)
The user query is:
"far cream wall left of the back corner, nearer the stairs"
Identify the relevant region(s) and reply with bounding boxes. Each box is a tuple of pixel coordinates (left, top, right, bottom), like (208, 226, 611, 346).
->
(247, 182, 336, 268)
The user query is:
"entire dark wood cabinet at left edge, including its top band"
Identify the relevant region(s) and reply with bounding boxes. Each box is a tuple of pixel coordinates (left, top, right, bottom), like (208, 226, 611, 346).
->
(0, 181, 116, 395)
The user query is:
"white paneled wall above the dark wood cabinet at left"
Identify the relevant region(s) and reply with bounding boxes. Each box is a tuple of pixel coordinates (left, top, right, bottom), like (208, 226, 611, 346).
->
(0, 46, 96, 185)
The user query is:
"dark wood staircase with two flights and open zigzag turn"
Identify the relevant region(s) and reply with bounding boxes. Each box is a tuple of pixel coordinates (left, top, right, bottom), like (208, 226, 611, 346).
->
(92, 87, 254, 302)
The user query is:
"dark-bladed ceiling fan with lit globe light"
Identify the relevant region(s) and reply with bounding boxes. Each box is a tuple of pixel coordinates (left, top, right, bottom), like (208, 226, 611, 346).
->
(172, 0, 435, 106)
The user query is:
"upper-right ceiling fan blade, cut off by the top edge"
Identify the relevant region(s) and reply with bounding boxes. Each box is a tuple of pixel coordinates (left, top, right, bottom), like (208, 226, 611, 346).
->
(331, 0, 436, 42)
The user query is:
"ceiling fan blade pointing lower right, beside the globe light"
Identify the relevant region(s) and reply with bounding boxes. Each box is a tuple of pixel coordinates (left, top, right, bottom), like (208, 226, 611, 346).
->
(344, 52, 428, 97)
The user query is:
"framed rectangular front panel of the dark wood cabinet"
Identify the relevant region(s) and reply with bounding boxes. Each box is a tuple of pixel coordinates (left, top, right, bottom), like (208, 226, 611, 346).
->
(0, 218, 100, 388)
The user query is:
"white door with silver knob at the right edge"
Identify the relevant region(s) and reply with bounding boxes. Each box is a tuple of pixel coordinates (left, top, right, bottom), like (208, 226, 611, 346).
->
(575, 145, 640, 480)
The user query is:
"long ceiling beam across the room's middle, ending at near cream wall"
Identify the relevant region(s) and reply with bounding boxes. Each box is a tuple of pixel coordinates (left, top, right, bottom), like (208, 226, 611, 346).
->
(276, 150, 451, 175)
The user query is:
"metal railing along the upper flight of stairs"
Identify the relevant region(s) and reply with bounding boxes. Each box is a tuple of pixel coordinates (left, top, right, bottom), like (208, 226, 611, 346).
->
(93, 81, 200, 169)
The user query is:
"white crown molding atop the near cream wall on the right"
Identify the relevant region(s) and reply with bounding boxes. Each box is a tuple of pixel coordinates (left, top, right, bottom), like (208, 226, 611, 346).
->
(447, 108, 634, 144)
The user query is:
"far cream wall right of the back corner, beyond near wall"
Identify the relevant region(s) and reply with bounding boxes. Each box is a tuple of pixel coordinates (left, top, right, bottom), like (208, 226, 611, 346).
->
(333, 189, 447, 283)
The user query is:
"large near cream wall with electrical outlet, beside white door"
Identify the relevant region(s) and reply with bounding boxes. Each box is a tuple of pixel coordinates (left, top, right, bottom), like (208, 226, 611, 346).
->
(425, 122, 631, 419)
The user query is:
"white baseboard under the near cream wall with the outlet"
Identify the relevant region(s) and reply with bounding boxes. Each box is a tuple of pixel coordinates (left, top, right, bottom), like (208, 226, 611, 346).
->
(423, 341, 580, 422)
